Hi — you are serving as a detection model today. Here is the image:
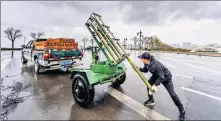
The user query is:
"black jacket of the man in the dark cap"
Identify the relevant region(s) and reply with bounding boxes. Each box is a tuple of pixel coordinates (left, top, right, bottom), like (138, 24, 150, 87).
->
(140, 56, 172, 85)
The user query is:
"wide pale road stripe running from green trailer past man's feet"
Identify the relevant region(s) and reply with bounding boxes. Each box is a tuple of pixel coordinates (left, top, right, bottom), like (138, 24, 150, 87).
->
(105, 87, 170, 120)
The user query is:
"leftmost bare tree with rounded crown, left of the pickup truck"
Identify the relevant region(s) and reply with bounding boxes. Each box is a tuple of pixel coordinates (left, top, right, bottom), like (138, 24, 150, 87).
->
(4, 27, 22, 57)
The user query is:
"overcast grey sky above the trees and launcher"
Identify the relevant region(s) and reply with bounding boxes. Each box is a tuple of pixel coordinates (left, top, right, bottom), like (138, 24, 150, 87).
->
(1, 1, 221, 47)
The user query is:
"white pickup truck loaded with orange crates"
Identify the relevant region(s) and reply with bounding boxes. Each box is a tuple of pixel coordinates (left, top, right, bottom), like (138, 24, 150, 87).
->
(21, 38, 83, 74)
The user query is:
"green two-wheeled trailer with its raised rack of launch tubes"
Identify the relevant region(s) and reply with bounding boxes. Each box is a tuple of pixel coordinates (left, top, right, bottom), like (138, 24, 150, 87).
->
(71, 13, 154, 108)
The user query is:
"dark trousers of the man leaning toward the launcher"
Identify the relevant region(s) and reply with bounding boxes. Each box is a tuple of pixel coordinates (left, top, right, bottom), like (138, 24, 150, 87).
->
(147, 75, 184, 111)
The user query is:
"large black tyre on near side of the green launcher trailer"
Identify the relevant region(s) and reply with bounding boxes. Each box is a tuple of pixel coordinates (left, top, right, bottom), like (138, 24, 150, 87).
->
(72, 74, 94, 108)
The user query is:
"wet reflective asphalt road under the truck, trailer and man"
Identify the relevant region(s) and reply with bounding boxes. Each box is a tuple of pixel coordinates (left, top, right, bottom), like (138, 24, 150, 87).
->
(1, 51, 221, 120)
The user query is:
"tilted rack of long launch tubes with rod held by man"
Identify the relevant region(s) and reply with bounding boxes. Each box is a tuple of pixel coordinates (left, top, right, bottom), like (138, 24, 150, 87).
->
(86, 13, 151, 89)
